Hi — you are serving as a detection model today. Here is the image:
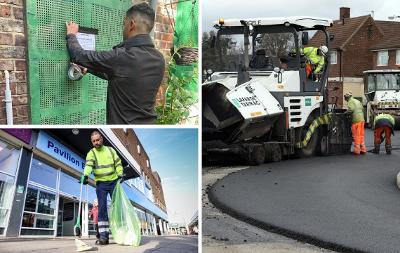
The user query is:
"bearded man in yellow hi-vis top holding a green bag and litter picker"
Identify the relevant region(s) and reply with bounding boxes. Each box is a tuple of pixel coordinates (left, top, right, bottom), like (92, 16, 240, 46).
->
(81, 131, 123, 245)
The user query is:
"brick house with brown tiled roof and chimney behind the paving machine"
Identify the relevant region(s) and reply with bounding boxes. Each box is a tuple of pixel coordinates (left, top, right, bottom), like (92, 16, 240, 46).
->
(310, 7, 394, 107)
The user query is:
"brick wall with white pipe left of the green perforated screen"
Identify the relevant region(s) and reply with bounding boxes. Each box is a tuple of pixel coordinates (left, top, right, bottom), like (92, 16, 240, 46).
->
(0, 0, 29, 124)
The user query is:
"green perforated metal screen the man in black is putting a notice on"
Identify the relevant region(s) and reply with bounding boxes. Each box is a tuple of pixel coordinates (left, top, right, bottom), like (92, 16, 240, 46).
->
(26, 0, 131, 125)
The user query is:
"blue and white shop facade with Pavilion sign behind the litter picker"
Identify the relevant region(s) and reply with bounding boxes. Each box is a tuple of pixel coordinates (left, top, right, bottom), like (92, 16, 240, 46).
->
(0, 129, 168, 237)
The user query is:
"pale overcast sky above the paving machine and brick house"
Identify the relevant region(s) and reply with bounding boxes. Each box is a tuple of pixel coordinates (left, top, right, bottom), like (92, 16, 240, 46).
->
(201, 0, 400, 31)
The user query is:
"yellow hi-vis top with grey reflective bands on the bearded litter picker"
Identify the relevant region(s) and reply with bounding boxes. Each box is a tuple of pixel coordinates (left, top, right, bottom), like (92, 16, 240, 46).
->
(83, 146, 123, 182)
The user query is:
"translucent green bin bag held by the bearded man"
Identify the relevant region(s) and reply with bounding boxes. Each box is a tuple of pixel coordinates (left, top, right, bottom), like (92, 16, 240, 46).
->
(108, 182, 140, 246)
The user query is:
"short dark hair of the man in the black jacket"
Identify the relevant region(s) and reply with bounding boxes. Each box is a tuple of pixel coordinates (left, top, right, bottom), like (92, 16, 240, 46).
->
(126, 2, 156, 32)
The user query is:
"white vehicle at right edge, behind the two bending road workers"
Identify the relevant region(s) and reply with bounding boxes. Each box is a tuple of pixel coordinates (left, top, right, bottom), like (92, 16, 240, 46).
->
(363, 69, 400, 128)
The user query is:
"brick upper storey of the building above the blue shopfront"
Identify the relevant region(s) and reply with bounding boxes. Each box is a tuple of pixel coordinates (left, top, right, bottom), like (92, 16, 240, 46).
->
(113, 129, 167, 212)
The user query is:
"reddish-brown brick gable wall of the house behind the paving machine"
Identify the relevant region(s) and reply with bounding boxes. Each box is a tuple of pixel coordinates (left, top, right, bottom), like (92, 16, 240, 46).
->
(329, 18, 382, 77)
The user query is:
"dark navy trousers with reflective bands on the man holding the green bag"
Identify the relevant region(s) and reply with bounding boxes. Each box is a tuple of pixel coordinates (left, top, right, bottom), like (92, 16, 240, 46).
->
(96, 180, 117, 240)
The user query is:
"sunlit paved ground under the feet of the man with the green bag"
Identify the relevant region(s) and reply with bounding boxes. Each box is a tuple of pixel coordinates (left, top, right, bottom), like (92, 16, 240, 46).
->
(0, 235, 198, 253)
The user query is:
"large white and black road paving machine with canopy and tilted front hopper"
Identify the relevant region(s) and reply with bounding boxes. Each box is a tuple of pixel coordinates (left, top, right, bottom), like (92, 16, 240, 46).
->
(202, 16, 351, 165)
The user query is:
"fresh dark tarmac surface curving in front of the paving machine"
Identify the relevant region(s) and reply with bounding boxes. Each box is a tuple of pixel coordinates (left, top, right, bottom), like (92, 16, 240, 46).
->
(208, 130, 400, 253)
